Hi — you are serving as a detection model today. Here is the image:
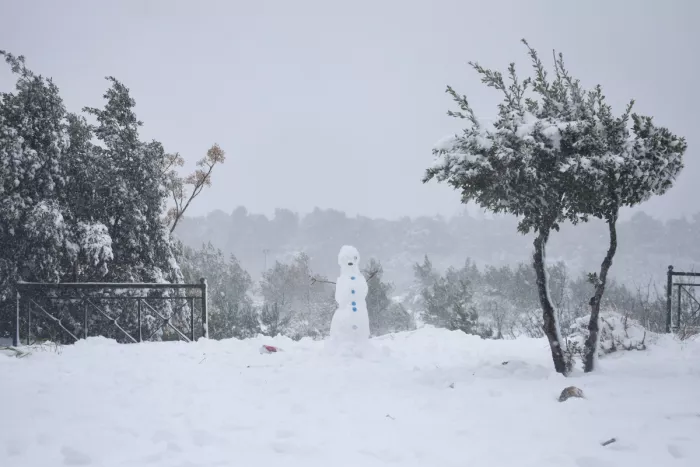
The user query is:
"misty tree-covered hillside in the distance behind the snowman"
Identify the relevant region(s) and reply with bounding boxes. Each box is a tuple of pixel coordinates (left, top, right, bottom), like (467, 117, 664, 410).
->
(176, 207, 700, 290)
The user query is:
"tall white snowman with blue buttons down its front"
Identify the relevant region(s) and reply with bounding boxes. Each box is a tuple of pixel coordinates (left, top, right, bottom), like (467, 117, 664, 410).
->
(330, 245, 369, 344)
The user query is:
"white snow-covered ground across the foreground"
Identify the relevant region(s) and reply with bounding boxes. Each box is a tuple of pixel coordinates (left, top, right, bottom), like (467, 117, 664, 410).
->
(0, 328, 700, 467)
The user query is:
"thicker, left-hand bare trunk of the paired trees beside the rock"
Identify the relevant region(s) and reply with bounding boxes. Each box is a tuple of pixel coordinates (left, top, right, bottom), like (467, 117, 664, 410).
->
(533, 229, 566, 375)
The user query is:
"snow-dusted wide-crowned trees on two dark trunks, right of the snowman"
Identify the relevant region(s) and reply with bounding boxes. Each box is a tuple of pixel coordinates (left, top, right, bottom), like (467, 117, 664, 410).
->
(424, 41, 686, 373)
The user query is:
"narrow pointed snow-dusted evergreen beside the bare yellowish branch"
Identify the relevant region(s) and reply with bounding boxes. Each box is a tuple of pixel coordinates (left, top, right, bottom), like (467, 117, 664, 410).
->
(85, 77, 179, 282)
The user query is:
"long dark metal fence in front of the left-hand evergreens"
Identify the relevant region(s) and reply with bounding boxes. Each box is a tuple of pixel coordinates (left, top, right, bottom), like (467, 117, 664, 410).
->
(13, 279, 209, 346)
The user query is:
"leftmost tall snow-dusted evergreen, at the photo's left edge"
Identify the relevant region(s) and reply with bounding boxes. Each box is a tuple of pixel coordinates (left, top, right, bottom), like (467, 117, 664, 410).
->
(0, 51, 112, 332)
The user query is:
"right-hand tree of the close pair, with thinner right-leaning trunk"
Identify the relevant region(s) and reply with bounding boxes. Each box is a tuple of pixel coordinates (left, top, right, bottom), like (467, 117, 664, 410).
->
(516, 46, 687, 371)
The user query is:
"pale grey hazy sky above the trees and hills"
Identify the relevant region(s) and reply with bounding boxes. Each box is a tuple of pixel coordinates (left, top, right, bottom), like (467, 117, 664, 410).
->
(0, 0, 700, 218)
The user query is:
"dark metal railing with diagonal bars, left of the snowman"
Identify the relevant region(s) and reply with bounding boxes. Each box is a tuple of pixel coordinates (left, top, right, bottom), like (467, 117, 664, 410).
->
(12, 279, 209, 346)
